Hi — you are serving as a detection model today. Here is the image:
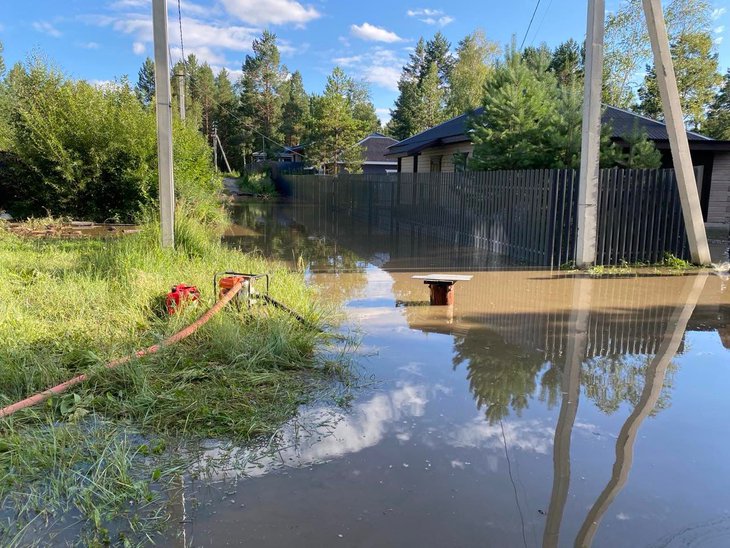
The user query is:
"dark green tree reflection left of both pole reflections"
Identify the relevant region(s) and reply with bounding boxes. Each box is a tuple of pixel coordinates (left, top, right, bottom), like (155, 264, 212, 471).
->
(453, 329, 560, 424)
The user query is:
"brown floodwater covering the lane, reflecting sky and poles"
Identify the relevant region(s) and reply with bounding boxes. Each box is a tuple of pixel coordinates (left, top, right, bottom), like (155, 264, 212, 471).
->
(170, 204, 730, 547)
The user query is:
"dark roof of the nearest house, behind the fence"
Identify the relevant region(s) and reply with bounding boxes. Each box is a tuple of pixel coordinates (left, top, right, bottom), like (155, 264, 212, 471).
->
(387, 107, 715, 157)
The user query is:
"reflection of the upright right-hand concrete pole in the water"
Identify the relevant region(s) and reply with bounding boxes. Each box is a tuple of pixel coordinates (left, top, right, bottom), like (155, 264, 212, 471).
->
(542, 278, 595, 547)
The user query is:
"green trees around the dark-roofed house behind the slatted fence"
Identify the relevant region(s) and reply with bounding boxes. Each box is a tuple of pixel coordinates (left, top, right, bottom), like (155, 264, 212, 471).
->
(386, 0, 730, 169)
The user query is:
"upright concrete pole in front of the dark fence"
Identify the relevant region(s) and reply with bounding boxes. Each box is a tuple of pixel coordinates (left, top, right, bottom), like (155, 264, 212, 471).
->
(575, 0, 606, 267)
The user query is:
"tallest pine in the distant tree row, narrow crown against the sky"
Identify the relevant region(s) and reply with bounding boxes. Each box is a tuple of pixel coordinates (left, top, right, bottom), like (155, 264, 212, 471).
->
(240, 30, 286, 156)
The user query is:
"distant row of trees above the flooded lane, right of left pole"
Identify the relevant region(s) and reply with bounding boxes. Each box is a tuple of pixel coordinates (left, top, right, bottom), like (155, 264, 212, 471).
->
(136, 31, 380, 172)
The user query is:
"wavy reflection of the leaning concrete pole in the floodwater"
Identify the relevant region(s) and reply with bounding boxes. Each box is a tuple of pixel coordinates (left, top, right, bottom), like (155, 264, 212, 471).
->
(575, 274, 707, 546)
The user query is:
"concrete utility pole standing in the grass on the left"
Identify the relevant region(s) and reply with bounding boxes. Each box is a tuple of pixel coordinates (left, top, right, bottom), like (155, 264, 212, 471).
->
(152, 0, 175, 247)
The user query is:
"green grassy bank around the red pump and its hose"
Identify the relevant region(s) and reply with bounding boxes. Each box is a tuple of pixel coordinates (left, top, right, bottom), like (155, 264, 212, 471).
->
(0, 212, 346, 546)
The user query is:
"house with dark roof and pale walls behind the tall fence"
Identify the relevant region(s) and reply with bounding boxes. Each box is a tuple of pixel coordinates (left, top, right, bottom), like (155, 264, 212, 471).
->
(386, 107, 730, 231)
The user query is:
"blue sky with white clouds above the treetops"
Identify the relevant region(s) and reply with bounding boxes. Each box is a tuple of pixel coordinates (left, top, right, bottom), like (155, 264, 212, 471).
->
(0, 0, 730, 123)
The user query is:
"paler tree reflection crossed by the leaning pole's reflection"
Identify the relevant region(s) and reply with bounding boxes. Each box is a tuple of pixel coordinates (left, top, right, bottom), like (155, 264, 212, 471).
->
(581, 355, 677, 415)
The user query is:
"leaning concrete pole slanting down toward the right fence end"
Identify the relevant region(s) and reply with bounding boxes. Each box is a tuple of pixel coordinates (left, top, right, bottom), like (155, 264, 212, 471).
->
(642, 0, 711, 265)
